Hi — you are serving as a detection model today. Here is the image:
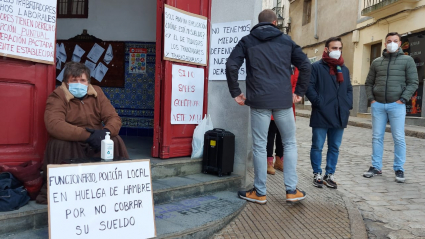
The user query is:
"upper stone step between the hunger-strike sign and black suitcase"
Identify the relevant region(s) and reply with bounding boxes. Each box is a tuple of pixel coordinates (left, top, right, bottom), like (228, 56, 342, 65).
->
(151, 157, 202, 179)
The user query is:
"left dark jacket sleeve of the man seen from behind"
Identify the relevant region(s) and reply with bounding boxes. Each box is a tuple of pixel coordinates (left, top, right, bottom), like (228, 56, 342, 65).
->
(226, 40, 245, 98)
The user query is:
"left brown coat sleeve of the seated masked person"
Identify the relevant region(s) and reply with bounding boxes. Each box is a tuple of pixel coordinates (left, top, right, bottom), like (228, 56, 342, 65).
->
(44, 93, 90, 142)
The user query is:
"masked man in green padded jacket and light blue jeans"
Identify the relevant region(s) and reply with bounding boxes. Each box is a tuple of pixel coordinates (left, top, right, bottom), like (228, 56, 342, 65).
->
(363, 32, 419, 183)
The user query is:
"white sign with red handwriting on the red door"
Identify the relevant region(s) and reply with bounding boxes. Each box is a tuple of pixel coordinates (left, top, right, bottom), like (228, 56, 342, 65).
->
(171, 65, 205, 124)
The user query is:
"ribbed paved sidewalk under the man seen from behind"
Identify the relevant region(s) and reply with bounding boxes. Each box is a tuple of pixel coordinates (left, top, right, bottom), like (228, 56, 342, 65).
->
(212, 169, 366, 239)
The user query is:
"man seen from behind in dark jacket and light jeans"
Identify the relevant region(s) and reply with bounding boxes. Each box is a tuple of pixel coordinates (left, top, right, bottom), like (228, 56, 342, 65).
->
(226, 10, 311, 204)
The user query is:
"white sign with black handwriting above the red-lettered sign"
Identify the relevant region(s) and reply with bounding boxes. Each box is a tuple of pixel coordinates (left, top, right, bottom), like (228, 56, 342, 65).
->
(164, 5, 208, 66)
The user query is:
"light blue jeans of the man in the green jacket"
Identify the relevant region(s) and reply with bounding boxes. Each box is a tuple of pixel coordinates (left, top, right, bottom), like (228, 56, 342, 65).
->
(371, 102, 406, 171)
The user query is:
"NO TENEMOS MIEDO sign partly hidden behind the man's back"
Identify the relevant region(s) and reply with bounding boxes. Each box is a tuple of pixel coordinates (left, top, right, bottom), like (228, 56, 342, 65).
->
(209, 20, 251, 80)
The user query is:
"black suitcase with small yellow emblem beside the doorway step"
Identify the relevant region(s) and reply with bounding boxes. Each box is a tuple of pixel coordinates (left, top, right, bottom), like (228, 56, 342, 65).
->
(202, 128, 235, 177)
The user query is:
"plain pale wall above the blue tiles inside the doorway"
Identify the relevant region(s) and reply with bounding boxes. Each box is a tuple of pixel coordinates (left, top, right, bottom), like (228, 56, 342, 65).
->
(56, 0, 156, 42)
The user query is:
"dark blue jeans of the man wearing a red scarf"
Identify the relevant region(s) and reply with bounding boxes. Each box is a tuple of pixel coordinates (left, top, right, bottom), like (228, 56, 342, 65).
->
(310, 128, 344, 175)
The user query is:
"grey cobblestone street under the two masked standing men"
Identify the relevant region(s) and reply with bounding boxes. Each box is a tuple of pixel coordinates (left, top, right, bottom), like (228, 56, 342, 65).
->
(297, 117, 425, 238)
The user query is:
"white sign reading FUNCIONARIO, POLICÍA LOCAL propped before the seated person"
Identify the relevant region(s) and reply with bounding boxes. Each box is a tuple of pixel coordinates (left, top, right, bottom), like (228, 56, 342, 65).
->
(47, 160, 156, 239)
